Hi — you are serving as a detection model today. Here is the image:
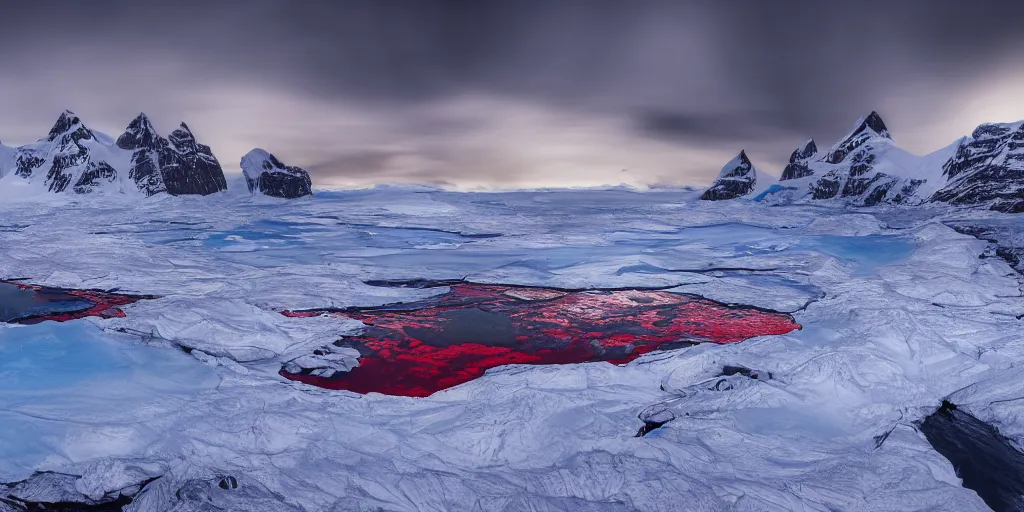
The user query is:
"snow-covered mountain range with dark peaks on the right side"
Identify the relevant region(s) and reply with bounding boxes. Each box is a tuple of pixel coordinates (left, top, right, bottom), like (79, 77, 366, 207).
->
(701, 112, 1024, 212)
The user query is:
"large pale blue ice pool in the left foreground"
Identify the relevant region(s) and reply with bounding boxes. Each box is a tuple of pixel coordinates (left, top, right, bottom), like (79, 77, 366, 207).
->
(0, 321, 220, 481)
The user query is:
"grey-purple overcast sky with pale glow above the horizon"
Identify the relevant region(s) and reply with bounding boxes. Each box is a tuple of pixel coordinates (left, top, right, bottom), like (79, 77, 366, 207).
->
(0, 0, 1024, 188)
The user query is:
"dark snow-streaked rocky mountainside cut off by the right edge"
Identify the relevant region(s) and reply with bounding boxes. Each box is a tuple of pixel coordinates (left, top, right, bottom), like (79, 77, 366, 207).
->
(932, 122, 1024, 213)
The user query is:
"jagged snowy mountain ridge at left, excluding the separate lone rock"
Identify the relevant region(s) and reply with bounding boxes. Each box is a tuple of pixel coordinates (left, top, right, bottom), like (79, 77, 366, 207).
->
(0, 111, 227, 196)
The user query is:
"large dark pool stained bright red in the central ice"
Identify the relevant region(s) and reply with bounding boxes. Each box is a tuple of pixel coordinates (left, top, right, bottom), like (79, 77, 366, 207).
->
(281, 284, 801, 396)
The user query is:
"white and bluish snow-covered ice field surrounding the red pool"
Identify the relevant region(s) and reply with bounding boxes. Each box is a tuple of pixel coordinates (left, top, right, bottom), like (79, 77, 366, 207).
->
(0, 187, 1024, 512)
